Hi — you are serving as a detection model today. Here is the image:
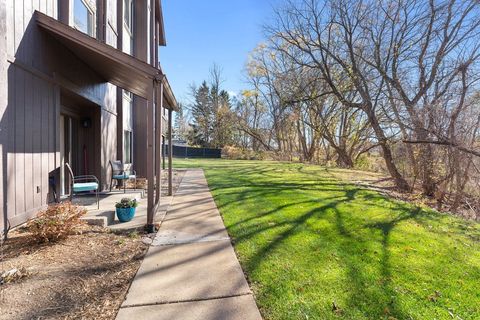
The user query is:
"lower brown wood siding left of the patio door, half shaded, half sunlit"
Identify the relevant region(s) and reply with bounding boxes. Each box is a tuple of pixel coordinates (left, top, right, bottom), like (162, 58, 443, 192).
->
(2, 65, 57, 225)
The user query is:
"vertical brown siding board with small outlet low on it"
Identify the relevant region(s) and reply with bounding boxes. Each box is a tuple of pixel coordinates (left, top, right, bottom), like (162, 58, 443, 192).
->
(32, 77, 44, 208)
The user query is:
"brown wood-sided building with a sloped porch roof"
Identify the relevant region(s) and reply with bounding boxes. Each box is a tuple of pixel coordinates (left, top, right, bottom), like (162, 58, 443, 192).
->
(0, 0, 177, 235)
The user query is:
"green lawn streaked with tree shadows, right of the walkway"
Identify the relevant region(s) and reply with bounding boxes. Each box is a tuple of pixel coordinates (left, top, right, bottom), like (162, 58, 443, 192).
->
(174, 159, 480, 320)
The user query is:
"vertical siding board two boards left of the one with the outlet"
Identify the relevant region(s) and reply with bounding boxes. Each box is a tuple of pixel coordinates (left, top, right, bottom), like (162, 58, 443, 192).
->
(15, 68, 25, 215)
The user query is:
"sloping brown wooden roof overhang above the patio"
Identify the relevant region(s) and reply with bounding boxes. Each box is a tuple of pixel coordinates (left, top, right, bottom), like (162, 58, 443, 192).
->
(34, 11, 163, 100)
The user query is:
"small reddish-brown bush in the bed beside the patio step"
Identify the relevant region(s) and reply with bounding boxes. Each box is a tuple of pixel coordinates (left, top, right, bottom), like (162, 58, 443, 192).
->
(27, 202, 87, 243)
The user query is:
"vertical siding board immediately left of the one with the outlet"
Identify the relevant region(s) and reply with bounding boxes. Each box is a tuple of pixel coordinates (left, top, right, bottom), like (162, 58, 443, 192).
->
(24, 73, 36, 210)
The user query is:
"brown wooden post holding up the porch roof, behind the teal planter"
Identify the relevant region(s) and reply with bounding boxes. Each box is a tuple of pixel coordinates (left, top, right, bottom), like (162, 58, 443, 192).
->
(146, 81, 155, 233)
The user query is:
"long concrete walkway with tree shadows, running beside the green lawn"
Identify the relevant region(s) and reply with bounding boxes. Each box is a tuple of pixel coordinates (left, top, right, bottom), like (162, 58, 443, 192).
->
(117, 170, 261, 320)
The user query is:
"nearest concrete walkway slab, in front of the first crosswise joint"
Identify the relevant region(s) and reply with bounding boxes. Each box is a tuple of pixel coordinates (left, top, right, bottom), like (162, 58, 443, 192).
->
(117, 295, 260, 320)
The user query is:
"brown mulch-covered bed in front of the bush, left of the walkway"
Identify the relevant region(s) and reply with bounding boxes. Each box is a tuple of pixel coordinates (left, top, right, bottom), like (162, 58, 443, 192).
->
(0, 226, 147, 320)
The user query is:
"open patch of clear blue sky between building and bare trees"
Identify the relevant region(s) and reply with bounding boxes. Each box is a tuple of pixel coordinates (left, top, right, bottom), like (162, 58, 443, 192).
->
(160, 0, 280, 102)
